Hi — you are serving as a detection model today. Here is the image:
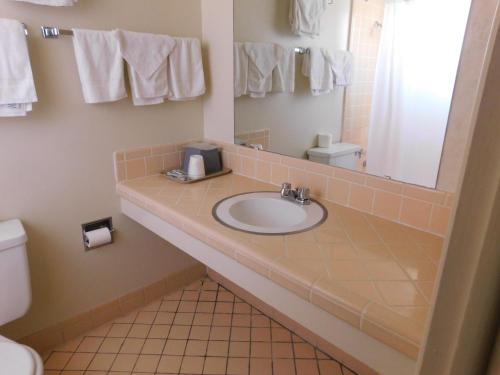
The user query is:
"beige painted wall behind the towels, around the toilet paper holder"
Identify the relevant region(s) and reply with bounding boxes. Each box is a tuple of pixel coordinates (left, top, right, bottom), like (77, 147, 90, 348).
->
(0, 0, 203, 338)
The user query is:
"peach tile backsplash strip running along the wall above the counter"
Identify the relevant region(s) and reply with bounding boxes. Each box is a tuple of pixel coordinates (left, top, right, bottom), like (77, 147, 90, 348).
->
(114, 140, 454, 236)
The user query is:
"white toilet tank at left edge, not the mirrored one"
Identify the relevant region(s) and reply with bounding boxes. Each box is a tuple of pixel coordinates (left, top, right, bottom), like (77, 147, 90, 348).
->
(0, 220, 31, 326)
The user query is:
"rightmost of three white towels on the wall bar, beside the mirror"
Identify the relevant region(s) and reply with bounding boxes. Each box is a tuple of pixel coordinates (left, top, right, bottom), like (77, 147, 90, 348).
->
(167, 38, 205, 101)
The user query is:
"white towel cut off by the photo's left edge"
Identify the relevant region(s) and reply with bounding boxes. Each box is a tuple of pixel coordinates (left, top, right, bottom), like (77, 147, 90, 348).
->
(0, 19, 38, 117)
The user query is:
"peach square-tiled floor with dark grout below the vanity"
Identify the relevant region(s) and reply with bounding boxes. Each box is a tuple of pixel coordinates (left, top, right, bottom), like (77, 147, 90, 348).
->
(44, 278, 355, 375)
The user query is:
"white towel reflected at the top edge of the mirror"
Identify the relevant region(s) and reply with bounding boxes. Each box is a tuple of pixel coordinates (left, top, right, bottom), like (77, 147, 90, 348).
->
(289, 0, 327, 38)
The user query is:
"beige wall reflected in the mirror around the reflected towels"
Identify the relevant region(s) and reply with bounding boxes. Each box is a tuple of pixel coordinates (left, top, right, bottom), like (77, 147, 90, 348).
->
(234, 0, 351, 158)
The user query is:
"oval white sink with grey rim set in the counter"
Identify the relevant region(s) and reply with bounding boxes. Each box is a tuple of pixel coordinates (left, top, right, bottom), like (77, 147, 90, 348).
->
(212, 192, 328, 235)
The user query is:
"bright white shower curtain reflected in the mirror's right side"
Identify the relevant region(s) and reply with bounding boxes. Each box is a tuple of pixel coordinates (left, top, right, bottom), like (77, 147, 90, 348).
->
(367, 0, 470, 188)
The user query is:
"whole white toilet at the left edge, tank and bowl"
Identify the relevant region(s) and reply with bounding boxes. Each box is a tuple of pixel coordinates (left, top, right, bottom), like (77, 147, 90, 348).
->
(0, 220, 43, 375)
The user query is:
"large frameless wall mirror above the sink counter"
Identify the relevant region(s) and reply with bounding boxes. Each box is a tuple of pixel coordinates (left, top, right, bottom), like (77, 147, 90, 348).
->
(234, 0, 470, 188)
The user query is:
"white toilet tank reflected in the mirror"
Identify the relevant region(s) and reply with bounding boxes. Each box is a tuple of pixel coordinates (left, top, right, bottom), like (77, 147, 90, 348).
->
(307, 143, 363, 169)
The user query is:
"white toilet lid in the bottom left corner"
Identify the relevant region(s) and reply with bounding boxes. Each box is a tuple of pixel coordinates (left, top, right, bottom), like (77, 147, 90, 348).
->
(0, 342, 36, 375)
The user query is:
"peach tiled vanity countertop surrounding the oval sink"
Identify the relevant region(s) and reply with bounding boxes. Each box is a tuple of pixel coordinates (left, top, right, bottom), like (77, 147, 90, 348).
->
(117, 175, 442, 359)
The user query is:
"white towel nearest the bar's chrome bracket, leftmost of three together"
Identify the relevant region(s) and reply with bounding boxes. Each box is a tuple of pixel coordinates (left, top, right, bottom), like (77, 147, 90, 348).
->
(73, 29, 127, 104)
